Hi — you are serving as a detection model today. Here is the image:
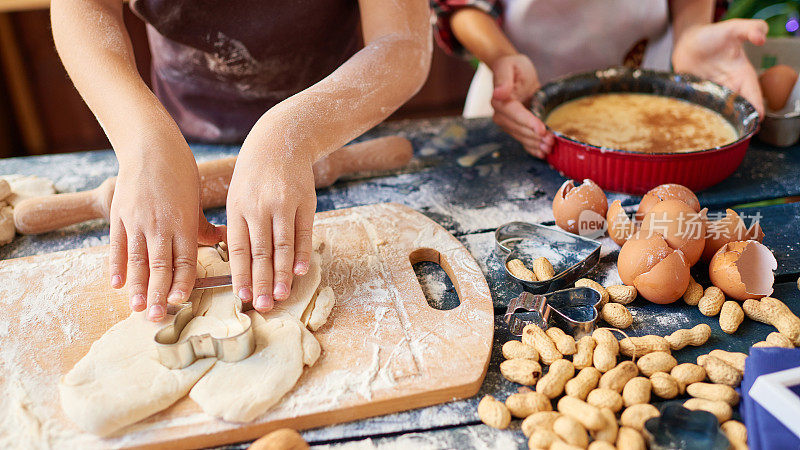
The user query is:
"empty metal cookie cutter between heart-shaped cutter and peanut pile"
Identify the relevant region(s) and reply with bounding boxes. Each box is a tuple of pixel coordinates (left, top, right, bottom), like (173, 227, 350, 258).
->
(504, 287, 601, 339)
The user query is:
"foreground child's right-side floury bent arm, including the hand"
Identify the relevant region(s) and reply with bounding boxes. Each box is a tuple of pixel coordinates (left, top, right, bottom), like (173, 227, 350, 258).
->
(222, 0, 432, 311)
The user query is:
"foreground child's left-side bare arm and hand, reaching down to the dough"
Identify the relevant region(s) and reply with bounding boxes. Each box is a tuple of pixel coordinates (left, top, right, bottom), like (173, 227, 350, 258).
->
(51, 0, 225, 320)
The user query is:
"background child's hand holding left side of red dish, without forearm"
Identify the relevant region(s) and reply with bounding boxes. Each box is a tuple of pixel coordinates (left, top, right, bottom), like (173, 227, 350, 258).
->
(491, 54, 554, 158)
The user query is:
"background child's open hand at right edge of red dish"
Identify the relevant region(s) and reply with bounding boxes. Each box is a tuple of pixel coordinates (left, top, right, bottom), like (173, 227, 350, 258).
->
(672, 19, 768, 117)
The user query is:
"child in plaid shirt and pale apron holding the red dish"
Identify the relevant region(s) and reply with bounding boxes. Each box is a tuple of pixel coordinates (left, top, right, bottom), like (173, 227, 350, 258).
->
(432, 0, 767, 158)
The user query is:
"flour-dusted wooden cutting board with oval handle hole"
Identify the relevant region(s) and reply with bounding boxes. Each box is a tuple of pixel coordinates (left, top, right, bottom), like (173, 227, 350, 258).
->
(0, 204, 494, 448)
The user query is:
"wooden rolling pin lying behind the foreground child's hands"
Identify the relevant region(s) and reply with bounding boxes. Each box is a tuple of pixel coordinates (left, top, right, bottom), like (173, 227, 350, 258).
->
(14, 136, 413, 234)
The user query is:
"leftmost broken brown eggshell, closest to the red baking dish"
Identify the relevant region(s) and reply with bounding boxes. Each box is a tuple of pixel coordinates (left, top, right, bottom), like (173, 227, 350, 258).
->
(553, 180, 608, 234)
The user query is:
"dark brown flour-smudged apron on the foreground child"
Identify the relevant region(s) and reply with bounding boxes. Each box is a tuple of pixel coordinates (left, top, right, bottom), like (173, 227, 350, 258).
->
(131, 0, 362, 143)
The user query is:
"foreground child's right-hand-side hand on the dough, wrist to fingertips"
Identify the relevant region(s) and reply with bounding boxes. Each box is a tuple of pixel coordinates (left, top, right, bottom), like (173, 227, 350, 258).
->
(227, 132, 317, 312)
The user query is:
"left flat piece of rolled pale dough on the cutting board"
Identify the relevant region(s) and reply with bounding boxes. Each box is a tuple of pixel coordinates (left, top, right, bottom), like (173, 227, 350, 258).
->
(58, 312, 216, 436)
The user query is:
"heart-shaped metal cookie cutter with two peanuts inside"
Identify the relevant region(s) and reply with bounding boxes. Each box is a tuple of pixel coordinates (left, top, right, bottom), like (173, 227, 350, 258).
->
(494, 222, 602, 294)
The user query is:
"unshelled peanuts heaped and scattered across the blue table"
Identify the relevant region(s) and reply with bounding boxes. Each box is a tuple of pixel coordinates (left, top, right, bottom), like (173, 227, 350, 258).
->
(478, 268, 800, 450)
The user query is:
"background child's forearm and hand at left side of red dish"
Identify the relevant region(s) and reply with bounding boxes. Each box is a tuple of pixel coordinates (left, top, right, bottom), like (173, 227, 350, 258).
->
(450, 8, 554, 158)
